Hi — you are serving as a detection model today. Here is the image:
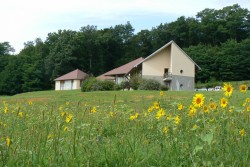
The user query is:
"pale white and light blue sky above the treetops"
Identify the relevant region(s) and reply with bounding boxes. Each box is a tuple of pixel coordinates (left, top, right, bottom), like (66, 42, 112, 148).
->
(0, 0, 250, 54)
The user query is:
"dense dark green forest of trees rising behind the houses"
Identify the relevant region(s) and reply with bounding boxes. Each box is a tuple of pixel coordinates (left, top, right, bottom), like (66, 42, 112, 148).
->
(0, 4, 250, 95)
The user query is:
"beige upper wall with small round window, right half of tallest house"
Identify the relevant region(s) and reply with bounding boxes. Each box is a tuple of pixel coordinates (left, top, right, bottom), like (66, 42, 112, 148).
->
(171, 43, 195, 77)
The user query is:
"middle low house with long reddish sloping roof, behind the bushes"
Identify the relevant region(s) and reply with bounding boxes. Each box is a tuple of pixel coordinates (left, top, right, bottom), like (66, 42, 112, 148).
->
(97, 57, 143, 84)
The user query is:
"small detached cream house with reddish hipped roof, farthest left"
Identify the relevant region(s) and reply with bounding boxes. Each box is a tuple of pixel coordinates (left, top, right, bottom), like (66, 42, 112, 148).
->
(55, 69, 88, 90)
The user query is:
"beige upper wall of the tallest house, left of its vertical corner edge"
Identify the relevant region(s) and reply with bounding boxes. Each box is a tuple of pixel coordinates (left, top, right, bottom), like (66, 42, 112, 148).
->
(142, 47, 171, 76)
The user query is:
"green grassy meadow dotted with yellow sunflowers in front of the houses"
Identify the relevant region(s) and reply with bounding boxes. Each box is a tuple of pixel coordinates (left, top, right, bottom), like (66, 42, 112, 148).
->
(0, 83, 250, 167)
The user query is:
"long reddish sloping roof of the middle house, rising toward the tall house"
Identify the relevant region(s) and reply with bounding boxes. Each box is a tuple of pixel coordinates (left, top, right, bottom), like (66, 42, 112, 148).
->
(103, 57, 143, 76)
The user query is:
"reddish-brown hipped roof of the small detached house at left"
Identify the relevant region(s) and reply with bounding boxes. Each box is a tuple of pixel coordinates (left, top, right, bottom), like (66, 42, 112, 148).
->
(55, 69, 88, 81)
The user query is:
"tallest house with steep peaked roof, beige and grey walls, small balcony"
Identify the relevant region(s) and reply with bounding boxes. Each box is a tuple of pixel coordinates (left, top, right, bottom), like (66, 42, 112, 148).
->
(129, 41, 201, 91)
